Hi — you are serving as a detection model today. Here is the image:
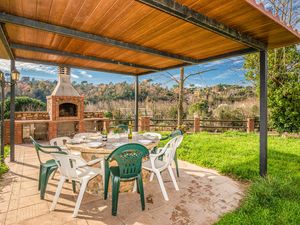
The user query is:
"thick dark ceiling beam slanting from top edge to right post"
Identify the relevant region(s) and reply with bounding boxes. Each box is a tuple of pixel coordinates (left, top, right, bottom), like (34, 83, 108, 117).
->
(137, 0, 267, 50)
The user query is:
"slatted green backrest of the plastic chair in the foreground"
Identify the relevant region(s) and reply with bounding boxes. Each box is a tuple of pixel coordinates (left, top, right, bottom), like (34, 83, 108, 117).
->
(106, 143, 149, 179)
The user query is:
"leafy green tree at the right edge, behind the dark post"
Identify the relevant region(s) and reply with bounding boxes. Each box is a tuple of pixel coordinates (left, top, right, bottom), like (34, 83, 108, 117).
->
(244, 0, 300, 132)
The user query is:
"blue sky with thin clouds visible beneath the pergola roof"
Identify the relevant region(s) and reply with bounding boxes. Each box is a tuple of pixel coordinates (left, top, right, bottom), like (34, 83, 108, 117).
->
(0, 57, 249, 87)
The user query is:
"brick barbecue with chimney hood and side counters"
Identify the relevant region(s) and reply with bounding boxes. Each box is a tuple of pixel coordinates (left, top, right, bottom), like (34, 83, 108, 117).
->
(5, 67, 109, 144)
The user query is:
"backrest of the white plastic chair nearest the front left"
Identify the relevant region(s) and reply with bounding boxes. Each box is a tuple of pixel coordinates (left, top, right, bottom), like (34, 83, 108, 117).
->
(51, 152, 78, 179)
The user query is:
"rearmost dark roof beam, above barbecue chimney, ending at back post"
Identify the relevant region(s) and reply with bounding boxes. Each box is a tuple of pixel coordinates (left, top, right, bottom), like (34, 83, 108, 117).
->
(16, 57, 136, 76)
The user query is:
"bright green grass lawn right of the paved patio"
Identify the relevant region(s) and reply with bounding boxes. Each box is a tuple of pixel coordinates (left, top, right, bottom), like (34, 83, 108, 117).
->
(178, 132, 300, 225)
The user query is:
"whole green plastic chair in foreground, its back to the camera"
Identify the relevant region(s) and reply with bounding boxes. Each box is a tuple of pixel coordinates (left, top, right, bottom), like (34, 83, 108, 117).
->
(104, 143, 149, 216)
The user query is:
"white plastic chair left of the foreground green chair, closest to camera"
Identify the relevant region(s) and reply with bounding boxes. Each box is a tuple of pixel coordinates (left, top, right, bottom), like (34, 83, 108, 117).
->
(50, 153, 104, 217)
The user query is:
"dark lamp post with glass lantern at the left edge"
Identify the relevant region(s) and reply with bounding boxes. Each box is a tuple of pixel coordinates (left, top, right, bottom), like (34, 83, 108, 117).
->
(0, 69, 20, 162)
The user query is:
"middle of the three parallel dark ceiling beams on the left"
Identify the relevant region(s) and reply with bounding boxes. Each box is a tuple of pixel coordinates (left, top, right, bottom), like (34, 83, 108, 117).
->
(10, 43, 160, 71)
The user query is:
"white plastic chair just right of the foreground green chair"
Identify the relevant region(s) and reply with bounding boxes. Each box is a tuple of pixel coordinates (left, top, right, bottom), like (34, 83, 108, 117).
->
(143, 135, 183, 201)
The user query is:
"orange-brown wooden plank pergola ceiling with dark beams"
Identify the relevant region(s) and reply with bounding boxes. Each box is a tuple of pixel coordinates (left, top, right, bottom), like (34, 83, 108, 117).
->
(0, 0, 300, 75)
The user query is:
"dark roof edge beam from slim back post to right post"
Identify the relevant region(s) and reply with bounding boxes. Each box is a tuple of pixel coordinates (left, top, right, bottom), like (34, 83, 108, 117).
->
(138, 48, 257, 76)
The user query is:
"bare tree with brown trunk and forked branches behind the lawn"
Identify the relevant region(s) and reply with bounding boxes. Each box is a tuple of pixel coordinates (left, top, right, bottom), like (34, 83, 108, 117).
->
(167, 67, 214, 126)
